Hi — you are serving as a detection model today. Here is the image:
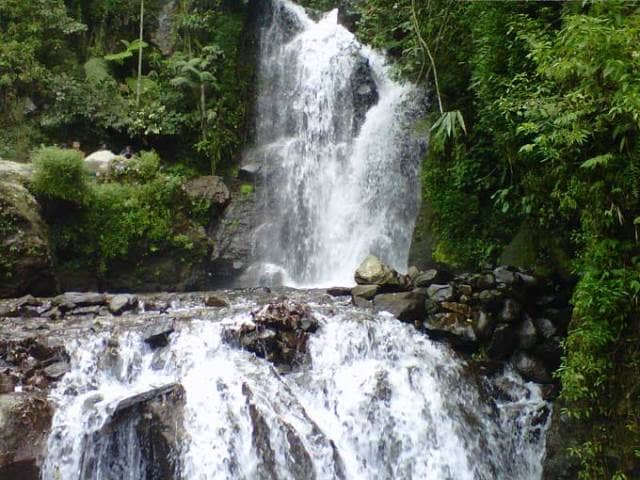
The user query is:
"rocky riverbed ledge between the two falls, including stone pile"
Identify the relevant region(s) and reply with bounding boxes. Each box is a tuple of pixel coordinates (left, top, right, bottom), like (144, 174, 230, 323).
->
(0, 257, 570, 479)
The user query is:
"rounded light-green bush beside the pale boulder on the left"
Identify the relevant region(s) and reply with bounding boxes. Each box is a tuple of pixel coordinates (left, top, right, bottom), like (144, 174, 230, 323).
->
(32, 147, 89, 206)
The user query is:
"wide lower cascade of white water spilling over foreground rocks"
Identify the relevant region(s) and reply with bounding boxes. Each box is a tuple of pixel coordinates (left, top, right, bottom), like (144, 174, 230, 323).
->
(43, 296, 546, 480)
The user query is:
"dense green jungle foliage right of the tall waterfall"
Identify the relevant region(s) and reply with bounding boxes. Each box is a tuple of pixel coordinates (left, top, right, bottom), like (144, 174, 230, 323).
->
(306, 0, 640, 479)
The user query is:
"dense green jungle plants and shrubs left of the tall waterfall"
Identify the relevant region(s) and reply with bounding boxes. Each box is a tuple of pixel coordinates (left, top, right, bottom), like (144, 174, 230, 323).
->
(0, 0, 255, 278)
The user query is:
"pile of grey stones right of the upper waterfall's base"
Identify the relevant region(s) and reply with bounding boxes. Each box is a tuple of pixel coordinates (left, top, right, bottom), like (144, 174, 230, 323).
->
(340, 256, 571, 383)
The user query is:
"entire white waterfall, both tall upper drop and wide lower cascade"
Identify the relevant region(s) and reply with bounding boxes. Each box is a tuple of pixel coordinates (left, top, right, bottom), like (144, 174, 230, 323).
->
(42, 0, 549, 480)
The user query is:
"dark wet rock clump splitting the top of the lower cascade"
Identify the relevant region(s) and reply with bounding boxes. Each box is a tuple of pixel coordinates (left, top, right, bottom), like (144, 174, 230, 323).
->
(226, 301, 318, 366)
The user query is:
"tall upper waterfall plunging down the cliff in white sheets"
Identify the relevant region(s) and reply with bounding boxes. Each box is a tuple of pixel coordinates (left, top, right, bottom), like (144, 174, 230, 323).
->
(245, 0, 423, 286)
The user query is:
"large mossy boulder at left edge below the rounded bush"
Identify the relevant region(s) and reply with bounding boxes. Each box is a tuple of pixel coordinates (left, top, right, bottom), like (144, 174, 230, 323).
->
(0, 178, 57, 297)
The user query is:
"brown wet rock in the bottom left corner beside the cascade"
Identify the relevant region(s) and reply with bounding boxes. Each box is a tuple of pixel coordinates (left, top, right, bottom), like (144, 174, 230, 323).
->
(0, 393, 52, 480)
